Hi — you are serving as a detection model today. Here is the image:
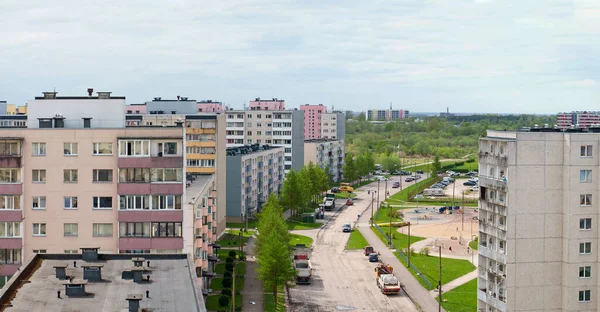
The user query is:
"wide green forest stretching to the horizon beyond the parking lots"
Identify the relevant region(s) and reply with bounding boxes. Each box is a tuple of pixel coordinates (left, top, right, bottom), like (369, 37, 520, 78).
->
(346, 114, 556, 159)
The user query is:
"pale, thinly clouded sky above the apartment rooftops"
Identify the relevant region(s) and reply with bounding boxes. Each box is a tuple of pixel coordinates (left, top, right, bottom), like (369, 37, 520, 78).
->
(0, 0, 600, 114)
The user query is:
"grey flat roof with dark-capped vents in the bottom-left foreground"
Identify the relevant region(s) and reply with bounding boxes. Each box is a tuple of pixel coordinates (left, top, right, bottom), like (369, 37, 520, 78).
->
(0, 254, 206, 312)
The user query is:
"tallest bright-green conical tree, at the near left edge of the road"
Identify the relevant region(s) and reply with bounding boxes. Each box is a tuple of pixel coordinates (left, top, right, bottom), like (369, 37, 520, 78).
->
(255, 195, 296, 304)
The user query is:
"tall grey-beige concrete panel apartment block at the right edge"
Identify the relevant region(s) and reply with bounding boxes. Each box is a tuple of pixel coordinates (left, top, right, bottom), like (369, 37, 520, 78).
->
(477, 127, 600, 312)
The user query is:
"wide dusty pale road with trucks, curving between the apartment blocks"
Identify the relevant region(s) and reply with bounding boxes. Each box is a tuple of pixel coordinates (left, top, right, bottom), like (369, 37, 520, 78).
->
(290, 177, 425, 312)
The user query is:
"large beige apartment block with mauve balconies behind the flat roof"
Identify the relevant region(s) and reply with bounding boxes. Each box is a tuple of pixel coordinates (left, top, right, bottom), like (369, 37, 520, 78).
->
(0, 91, 224, 283)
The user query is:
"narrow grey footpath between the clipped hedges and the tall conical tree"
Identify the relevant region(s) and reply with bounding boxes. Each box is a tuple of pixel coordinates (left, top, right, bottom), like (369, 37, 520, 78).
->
(242, 237, 264, 312)
